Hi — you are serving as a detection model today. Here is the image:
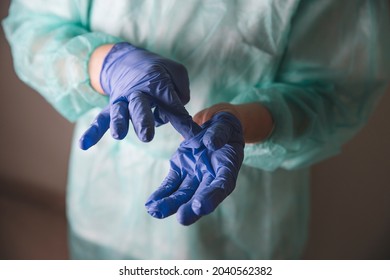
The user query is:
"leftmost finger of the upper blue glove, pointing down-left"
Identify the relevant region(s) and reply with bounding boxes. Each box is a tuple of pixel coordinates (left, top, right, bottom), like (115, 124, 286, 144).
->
(79, 106, 110, 150)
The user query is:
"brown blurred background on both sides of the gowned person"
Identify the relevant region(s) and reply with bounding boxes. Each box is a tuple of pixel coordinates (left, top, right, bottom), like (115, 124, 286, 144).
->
(0, 0, 390, 259)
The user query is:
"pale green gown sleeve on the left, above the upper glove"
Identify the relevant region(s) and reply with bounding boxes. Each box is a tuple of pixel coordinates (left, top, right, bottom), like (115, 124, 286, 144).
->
(2, 0, 120, 121)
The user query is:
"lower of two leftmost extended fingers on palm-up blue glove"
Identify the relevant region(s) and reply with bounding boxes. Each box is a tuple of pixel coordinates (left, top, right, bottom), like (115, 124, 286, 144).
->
(147, 176, 199, 219)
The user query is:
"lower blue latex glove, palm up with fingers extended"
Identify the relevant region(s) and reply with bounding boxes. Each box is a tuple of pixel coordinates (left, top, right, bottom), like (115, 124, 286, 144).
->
(145, 112, 245, 225)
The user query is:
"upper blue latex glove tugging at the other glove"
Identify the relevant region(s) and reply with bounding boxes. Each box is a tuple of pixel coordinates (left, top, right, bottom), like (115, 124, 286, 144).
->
(80, 43, 199, 150)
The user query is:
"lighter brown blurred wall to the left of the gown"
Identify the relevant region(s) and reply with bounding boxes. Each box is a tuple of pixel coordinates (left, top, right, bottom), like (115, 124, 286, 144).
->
(0, 0, 72, 259)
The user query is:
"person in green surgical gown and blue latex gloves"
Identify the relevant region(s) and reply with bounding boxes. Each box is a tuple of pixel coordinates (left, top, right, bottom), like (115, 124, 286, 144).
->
(3, 0, 390, 259)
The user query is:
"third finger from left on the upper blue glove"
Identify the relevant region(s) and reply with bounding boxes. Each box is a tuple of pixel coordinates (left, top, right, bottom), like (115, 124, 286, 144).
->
(129, 92, 154, 142)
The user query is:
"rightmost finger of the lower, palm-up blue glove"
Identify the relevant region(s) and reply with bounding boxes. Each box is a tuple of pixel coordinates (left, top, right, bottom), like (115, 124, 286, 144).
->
(191, 167, 236, 216)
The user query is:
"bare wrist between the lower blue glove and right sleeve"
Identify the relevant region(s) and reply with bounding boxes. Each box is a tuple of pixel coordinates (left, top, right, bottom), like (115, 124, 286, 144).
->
(194, 102, 274, 143)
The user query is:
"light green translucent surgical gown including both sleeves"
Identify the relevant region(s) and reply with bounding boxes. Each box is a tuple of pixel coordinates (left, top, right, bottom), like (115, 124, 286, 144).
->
(3, 0, 390, 259)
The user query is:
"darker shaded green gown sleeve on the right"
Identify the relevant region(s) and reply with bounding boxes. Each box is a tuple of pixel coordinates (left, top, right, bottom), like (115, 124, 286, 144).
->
(233, 0, 390, 171)
